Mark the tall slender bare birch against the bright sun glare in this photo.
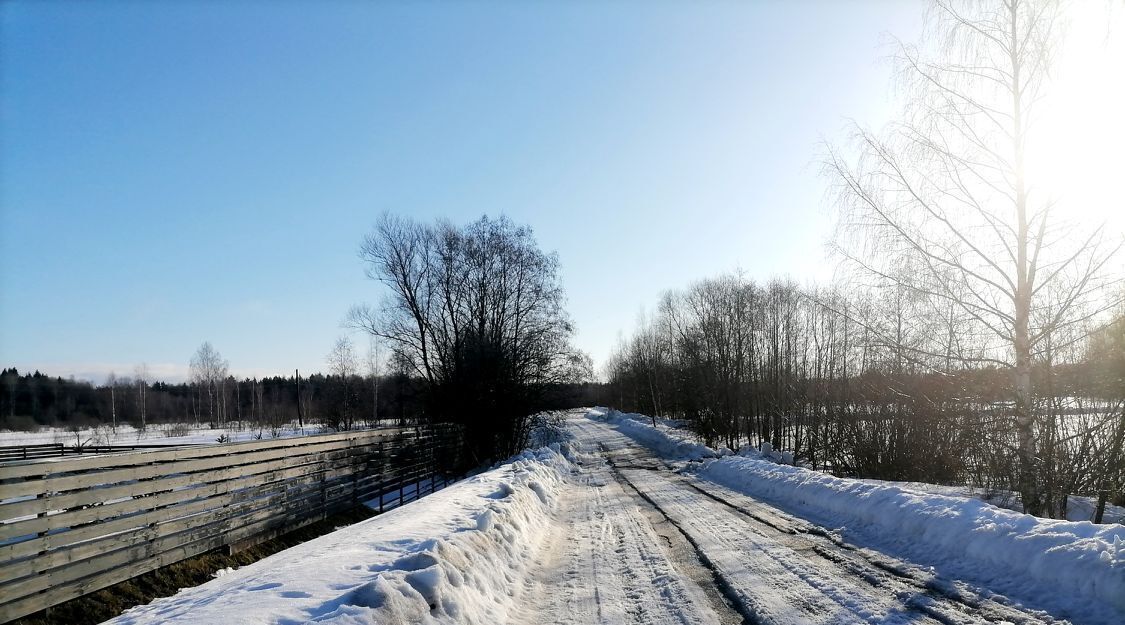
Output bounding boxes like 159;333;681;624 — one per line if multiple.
826;0;1121;514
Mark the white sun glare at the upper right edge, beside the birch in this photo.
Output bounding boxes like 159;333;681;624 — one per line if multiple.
1026;2;1125;233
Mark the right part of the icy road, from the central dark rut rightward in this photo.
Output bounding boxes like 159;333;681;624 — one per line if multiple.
573;422;1055;625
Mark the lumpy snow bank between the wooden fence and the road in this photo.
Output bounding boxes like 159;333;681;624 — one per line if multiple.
109;445;576;625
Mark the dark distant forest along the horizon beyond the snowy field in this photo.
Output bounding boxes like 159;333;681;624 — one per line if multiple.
0;368;601;431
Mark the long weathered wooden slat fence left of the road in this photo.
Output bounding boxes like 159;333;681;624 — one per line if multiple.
0;428;459;623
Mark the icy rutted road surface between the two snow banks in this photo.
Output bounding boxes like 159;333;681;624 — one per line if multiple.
528;418;1054;625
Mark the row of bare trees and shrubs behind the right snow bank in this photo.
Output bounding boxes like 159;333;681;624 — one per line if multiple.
606;274;1125;516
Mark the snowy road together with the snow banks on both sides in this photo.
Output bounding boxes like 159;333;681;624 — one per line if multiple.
101;410;1125;625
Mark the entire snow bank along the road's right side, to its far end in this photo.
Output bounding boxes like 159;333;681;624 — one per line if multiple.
603;408;1125;623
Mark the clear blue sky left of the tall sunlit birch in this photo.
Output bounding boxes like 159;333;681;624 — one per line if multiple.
0;0;924;379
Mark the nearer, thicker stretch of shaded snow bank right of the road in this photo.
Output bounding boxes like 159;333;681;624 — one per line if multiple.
698;456;1125;612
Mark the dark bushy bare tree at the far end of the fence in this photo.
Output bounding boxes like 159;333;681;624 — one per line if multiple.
349;215;583;460
